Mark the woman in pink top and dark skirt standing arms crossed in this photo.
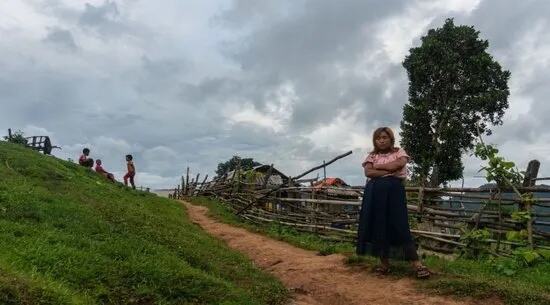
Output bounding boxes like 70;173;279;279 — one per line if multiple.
357;127;430;278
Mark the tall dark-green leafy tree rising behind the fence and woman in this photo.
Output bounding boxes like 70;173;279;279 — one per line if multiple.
401;19;510;187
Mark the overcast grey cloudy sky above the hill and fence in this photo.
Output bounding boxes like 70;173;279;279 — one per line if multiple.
0;0;550;187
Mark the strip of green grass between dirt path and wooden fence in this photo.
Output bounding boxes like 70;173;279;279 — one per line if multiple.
190;197;550;305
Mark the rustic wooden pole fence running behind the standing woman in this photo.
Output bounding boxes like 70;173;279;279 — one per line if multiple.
170;153;550;256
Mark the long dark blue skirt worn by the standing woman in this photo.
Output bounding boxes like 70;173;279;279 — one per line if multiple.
357;177;418;260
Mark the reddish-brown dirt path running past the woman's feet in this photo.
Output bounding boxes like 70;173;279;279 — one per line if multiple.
184;203;492;305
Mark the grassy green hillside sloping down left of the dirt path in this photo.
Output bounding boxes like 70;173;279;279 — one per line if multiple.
0;142;288;304
